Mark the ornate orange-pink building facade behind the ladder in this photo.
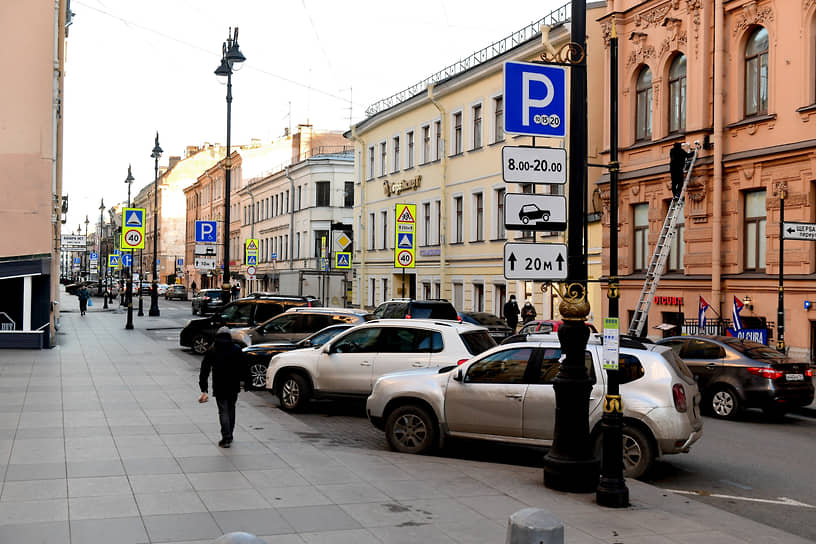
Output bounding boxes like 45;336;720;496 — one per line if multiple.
599;0;816;360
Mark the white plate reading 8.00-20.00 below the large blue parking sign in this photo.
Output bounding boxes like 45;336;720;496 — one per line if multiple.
502;146;567;185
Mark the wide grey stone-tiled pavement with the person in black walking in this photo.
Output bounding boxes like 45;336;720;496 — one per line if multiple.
0;304;807;544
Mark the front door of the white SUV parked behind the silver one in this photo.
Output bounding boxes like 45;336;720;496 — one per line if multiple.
315;327;382;395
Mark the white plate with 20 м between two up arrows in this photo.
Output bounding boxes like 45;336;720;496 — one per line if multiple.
504;242;567;281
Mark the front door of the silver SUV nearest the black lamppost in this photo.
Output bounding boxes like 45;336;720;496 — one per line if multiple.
445;347;533;438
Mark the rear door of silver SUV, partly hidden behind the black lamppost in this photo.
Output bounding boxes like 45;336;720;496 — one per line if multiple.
522;347;604;440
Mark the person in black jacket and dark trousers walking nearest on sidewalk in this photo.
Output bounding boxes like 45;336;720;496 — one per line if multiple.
198;327;243;448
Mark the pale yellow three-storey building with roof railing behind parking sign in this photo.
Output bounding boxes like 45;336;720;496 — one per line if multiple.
348;2;604;320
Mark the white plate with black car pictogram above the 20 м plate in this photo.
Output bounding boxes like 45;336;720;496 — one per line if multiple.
504;193;567;231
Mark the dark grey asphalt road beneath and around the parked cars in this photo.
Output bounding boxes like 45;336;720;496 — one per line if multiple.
147;299;816;541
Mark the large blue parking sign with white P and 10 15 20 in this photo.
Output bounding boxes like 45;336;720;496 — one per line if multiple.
504;62;567;138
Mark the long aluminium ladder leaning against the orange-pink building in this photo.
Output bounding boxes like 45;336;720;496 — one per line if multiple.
628;142;700;337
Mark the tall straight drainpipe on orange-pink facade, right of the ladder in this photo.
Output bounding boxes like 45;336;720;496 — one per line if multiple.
711;0;725;315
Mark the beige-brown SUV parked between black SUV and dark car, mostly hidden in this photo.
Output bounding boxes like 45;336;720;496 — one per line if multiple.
232;306;374;347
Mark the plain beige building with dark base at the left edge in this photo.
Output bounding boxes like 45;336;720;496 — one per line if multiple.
0;0;72;348
